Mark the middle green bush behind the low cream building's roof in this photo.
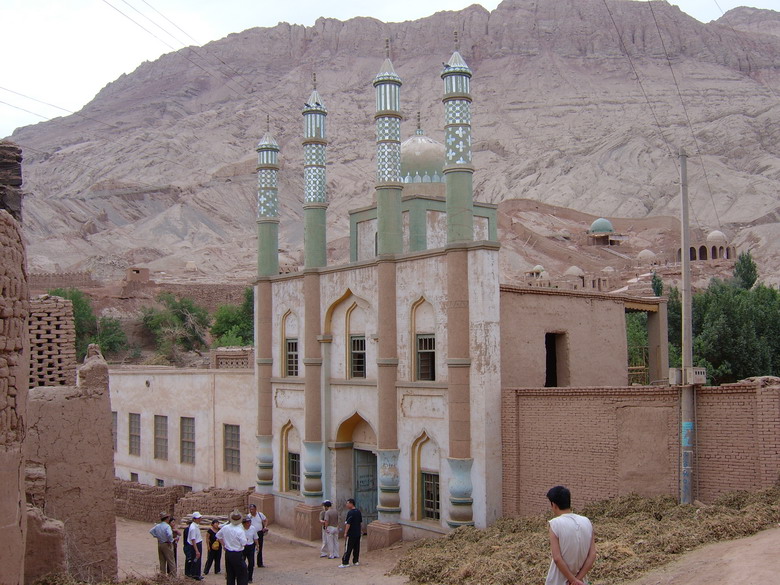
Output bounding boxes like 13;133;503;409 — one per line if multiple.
141;293;211;361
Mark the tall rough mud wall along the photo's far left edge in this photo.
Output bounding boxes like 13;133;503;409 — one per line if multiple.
0;209;29;583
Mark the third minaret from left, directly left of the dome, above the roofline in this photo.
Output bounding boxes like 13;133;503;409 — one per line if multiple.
374;40;403;256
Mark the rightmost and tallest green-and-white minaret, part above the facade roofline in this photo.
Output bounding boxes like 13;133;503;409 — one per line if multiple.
441;32;474;242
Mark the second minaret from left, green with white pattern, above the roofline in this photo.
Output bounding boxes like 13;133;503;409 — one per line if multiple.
303;75;328;268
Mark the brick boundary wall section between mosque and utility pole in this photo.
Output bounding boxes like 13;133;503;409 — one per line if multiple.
502;387;679;516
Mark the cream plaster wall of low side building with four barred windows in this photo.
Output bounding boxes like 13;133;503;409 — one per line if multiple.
109;368;257;490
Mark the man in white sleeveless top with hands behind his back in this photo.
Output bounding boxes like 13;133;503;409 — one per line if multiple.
545;485;596;585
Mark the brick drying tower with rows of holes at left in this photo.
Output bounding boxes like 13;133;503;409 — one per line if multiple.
28;295;76;388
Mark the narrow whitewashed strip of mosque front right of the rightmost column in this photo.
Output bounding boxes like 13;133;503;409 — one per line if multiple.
469;244;501;528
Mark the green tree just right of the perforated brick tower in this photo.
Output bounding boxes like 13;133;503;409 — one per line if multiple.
49;288;127;361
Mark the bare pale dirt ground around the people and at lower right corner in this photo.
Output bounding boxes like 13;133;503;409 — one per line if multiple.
117;518;780;585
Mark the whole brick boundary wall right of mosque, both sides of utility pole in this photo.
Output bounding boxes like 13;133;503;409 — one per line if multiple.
501;378;780;516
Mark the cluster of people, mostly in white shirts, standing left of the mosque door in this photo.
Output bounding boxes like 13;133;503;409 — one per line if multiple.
149;504;268;585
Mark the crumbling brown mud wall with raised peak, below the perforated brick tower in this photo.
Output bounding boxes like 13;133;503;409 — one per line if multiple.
24;346;117;581
